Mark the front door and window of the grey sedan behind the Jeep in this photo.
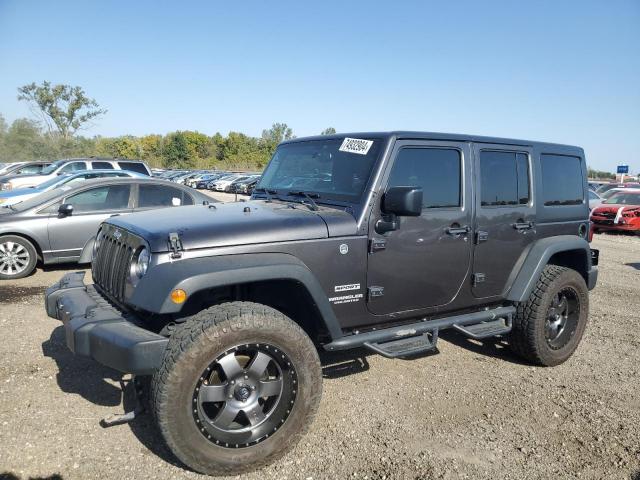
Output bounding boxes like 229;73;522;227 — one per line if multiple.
48;184;131;258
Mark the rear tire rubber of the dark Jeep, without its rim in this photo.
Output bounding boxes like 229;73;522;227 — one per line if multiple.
509;265;589;367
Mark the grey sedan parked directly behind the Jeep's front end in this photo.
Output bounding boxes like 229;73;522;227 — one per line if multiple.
0;178;214;280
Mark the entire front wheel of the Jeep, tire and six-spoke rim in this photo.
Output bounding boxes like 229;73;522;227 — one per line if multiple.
151;302;322;475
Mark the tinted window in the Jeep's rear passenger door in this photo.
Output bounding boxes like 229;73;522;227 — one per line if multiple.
480;150;530;206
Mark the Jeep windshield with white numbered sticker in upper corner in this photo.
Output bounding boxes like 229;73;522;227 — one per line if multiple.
257;138;382;203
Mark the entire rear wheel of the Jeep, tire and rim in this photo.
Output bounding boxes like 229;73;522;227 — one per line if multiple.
510;265;589;366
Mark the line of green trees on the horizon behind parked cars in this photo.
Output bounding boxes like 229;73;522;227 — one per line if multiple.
0;81;616;179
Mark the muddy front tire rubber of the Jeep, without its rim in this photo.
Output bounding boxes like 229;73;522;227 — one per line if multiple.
150;302;322;475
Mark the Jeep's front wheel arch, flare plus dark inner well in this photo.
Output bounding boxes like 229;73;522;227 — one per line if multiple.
127;253;342;339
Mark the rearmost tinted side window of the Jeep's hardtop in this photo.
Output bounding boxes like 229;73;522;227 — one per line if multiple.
540;154;584;206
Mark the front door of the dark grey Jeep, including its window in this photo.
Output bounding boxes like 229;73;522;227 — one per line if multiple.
367;141;472;315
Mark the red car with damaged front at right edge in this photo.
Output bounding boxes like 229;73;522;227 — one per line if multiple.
591;188;640;235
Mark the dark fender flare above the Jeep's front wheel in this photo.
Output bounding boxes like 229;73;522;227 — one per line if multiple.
127;253;342;339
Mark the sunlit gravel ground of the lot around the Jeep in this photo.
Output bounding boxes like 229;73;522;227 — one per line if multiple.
0;230;640;480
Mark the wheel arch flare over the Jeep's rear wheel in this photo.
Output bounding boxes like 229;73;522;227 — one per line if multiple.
506;235;591;302
